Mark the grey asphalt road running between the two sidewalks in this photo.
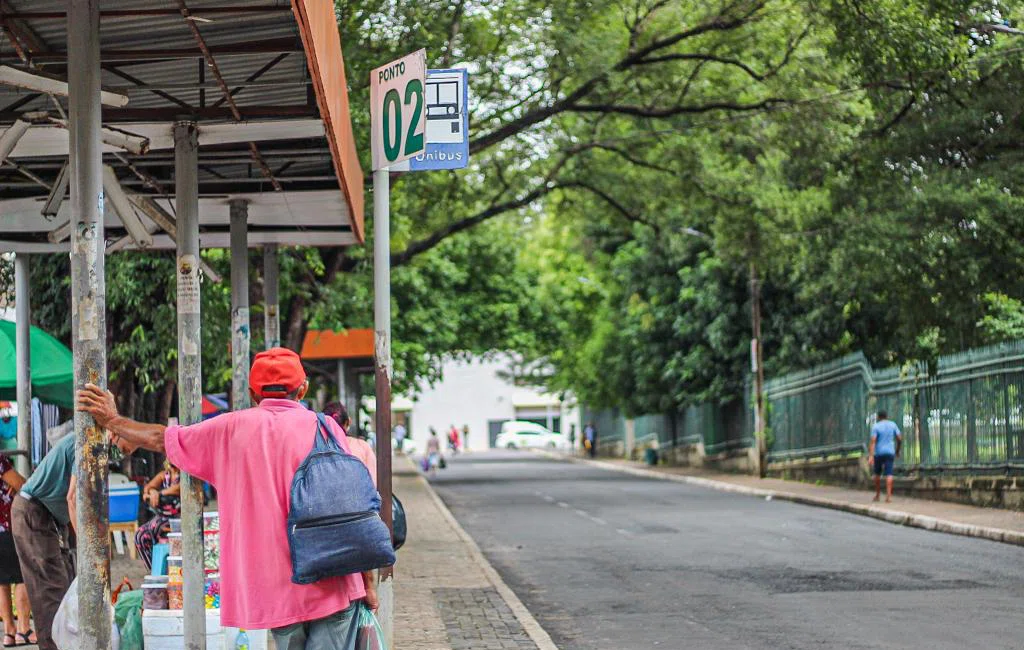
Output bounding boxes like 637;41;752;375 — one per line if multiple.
428;451;1024;650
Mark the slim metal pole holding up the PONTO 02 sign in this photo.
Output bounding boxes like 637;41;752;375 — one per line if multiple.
374;168;394;648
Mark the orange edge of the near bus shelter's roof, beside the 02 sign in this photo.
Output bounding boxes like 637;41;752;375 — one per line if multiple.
292;0;366;244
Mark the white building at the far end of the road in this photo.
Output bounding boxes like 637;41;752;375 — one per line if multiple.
392;357;581;451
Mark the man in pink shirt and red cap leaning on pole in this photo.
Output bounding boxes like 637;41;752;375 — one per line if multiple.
78;348;377;650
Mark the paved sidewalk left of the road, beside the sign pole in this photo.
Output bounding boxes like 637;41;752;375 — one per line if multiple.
394;456;557;650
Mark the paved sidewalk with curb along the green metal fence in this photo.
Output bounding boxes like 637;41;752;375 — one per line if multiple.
558;454;1024;546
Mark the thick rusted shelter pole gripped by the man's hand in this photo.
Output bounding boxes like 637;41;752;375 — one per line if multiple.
68;0;111;650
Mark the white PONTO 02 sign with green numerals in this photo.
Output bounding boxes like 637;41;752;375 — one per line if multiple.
370;49;427;170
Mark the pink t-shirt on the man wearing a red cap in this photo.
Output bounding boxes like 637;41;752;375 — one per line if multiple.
164;399;377;630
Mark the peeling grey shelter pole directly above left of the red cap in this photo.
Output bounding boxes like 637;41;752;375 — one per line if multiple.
230;199;250;410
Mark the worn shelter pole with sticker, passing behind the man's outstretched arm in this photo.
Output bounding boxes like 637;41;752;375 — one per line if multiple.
174;121;206;650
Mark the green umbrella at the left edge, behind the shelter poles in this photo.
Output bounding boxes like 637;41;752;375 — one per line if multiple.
0;320;75;408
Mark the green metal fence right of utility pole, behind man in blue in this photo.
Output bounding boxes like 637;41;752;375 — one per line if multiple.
765;341;1024;470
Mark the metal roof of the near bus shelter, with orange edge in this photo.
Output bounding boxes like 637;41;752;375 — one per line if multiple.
0;0;362;251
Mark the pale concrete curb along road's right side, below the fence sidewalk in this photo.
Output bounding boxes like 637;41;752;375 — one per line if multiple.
540;450;1024;547
